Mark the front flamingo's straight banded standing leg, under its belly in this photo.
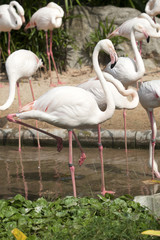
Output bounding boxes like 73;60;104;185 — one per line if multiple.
68;130;77;197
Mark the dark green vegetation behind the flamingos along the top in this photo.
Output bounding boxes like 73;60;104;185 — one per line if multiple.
0;0;147;71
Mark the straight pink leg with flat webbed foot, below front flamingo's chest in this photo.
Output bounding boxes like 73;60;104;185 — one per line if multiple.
98;124;115;195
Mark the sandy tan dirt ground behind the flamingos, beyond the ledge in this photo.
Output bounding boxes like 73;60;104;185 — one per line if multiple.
0;67;160;131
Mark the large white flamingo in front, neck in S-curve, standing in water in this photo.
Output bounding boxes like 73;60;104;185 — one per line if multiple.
7;39;138;197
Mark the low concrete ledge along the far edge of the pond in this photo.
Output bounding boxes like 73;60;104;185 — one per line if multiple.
0;128;160;148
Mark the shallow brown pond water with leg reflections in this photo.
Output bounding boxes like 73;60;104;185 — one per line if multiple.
0;146;160;200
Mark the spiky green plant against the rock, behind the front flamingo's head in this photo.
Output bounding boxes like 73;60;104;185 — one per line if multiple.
83;18;125;64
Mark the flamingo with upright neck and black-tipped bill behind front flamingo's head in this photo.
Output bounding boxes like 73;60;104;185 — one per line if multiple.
104;23;146;158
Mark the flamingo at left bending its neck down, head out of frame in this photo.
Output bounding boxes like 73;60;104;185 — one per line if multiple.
0;49;43;151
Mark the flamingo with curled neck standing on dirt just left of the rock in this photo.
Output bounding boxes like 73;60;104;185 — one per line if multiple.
25;2;64;86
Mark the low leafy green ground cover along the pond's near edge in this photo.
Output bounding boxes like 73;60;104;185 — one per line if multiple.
0;195;160;240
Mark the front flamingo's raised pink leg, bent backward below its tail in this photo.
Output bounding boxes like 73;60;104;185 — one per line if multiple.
7;113;63;152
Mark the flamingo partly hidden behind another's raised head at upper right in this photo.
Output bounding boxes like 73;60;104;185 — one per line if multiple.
108;13;160;54
